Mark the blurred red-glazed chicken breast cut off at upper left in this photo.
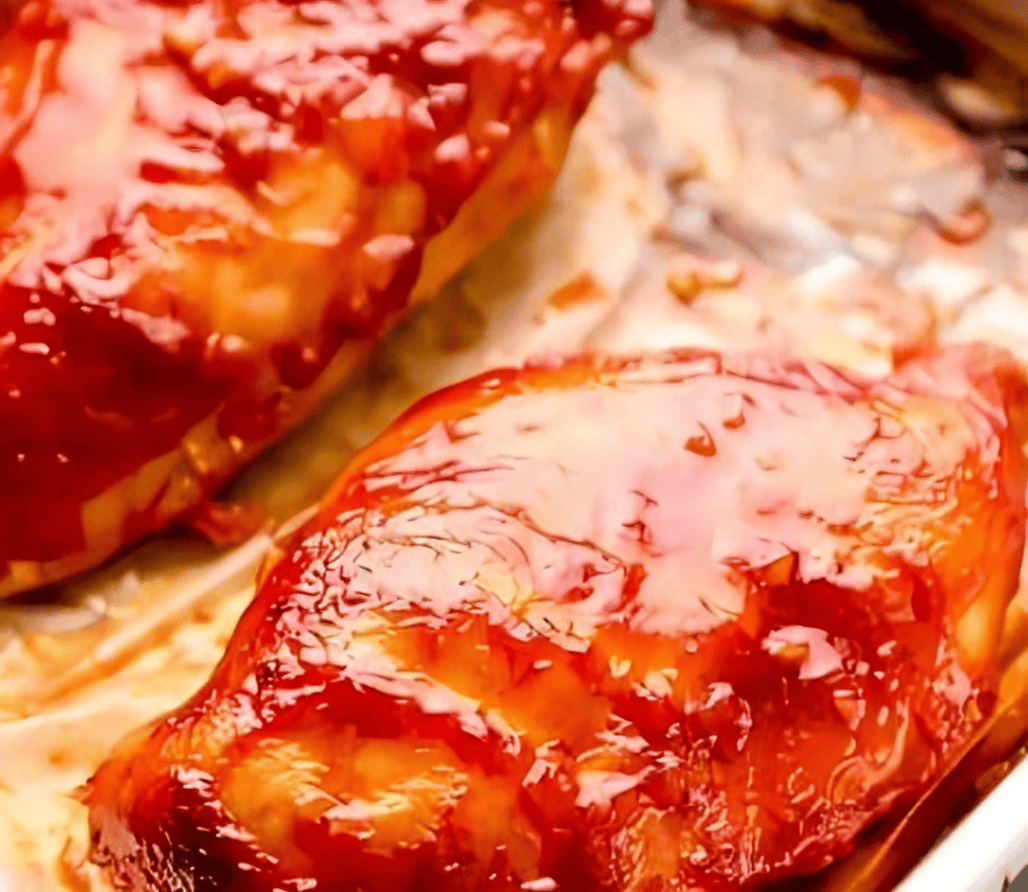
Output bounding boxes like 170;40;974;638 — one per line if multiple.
0;0;651;595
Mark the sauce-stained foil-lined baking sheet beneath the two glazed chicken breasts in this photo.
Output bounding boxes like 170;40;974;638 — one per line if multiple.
0;2;1028;892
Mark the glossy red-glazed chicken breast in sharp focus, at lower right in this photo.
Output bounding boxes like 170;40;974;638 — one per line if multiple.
84;349;1028;892
